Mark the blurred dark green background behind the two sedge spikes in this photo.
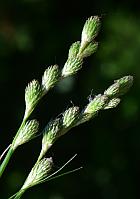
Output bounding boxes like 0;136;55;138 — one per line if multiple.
0;0;140;199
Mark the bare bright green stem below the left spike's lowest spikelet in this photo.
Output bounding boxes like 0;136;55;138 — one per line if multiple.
0;147;14;177
